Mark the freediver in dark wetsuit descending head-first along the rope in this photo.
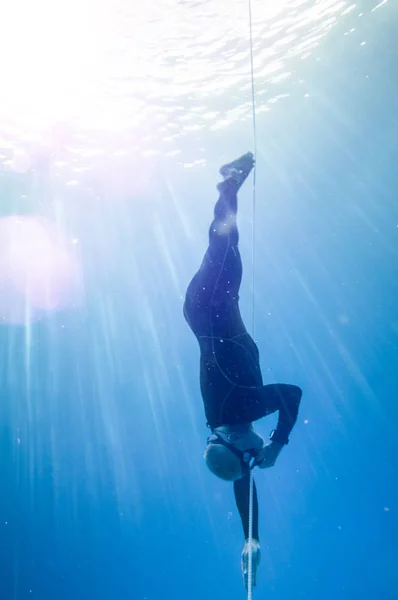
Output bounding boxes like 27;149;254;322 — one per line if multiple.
184;152;302;588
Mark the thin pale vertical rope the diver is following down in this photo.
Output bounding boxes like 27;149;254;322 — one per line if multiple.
247;0;257;600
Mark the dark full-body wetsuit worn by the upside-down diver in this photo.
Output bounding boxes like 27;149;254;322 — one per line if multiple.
184;180;301;539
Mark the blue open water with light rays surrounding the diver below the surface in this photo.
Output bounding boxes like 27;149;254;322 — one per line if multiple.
0;2;398;600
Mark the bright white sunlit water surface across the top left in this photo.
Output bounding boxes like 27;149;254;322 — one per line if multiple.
0;0;348;137
